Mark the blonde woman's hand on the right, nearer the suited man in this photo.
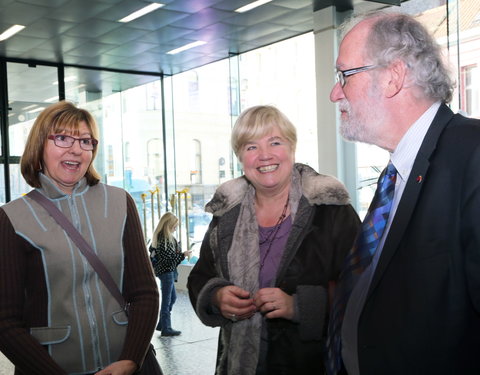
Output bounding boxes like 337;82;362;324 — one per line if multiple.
253;288;295;320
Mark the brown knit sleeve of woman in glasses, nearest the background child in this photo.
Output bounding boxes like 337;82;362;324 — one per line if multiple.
120;194;159;365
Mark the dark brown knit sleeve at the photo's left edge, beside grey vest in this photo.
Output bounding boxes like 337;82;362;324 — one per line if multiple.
0;208;66;375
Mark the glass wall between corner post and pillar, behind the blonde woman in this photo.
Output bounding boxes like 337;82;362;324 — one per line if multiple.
172;33;318;257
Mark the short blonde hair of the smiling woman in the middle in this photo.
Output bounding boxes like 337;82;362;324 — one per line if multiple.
231;105;297;159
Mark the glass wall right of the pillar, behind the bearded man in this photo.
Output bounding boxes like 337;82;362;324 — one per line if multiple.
356;0;480;217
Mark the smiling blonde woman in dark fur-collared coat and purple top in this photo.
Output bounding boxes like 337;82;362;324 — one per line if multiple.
188;106;359;375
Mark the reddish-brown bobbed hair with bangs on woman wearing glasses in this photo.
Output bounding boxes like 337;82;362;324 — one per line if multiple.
20;101;100;188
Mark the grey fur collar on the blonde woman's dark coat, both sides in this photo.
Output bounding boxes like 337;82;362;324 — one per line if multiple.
205;163;350;216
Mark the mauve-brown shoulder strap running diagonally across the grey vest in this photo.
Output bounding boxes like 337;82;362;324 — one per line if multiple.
27;190;127;311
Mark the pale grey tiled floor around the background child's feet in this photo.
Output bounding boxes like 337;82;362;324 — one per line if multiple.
0;291;219;375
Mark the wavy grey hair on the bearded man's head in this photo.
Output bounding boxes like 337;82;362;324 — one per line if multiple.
341;11;455;103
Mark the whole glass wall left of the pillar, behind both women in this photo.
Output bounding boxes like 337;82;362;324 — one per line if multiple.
2;30;317;255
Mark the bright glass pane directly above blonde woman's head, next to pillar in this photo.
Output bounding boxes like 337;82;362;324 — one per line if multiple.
239;33;318;170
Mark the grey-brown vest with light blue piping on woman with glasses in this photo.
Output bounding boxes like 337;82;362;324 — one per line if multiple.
2;175;128;374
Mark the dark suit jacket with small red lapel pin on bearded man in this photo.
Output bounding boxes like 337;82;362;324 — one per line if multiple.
358;105;480;375
